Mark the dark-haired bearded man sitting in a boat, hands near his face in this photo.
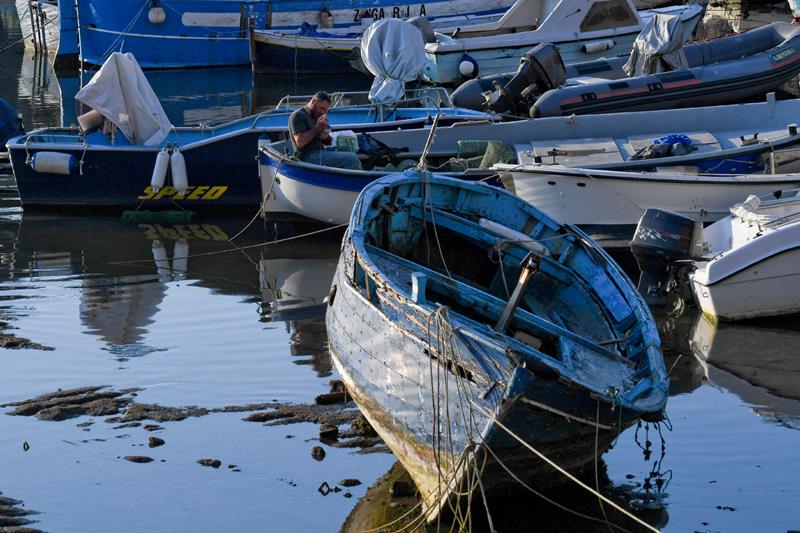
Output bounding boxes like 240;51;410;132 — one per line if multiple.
289;91;361;170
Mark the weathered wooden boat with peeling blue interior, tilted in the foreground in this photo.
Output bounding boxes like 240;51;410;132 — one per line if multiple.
326;170;668;519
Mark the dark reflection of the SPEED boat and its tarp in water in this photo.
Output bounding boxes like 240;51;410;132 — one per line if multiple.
4;215;263;358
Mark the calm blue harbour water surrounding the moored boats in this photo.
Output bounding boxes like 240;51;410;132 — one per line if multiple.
0;0;800;532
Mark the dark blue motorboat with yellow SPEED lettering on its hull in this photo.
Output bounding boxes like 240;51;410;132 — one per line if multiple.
8;102;489;210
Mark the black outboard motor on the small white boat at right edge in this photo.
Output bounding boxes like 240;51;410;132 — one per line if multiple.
631;208;703;304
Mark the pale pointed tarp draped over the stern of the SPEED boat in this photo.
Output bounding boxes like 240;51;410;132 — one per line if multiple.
75;52;172;146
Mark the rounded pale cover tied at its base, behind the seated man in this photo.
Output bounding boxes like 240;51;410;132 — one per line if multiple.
361;18;426;104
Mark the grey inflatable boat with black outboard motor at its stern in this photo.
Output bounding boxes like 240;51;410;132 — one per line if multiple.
452;22;800;118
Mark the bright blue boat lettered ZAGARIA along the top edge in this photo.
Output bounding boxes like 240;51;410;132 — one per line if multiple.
76;0;512;68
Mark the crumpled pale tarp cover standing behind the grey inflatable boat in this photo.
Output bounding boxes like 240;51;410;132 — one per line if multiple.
622;13;689;76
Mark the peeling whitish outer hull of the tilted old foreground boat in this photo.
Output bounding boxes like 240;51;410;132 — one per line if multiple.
327;260;638;517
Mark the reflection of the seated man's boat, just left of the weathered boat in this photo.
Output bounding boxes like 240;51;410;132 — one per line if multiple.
258;227;342;377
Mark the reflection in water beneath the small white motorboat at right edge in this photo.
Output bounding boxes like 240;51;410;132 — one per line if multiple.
690;315;800;429
